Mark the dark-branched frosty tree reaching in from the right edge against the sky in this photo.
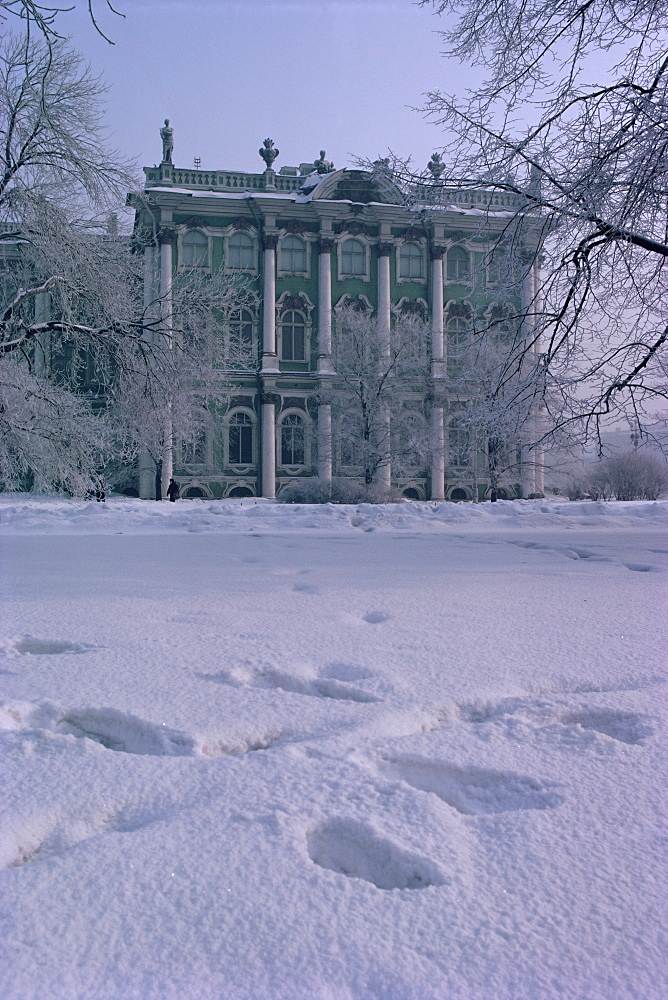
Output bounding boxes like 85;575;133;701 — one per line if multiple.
398;0;668;446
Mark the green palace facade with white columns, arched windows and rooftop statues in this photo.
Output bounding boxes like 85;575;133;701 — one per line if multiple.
129;133;543;500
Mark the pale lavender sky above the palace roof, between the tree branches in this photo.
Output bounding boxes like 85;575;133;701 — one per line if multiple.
58;0;474;182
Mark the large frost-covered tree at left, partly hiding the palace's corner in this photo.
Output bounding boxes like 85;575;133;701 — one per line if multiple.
0;34;249;492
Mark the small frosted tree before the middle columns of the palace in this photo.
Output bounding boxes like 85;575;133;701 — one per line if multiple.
333;305;430;486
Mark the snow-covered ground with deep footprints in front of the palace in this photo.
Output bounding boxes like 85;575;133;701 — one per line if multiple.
0;494;668;1000
